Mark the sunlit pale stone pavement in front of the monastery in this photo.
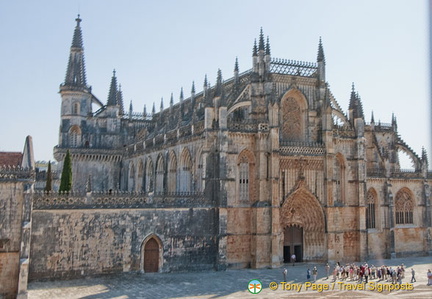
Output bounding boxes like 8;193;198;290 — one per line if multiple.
28;257;432;299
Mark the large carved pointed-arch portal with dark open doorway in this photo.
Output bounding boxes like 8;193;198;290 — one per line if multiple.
280;181;326;261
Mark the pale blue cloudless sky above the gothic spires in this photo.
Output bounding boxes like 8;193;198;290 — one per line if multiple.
0;0;430;166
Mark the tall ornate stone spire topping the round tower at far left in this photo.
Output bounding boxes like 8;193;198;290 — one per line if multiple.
61;15;90;90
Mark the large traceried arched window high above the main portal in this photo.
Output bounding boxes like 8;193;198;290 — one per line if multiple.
281;97;304;141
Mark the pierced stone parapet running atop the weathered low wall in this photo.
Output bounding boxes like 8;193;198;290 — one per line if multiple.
33;191;209;210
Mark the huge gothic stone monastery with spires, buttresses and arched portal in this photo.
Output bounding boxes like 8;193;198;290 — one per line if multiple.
0;17;432;298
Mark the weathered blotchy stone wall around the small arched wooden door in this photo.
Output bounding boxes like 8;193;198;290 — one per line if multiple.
30;204;217;280
